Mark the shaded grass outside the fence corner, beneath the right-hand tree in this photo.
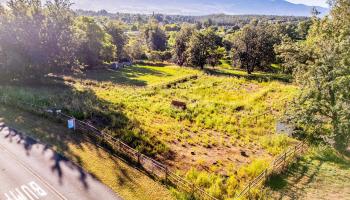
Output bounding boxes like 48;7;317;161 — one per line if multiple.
267;147;350;200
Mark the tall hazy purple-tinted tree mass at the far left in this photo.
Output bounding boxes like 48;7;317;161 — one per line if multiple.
0;0;76;78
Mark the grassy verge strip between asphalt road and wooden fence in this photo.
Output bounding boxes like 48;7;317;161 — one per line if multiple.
0;106;173;200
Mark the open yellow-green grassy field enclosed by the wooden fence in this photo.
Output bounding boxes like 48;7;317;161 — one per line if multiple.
0;65;298;198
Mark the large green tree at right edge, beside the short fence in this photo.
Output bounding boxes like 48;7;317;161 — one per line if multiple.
288;0;350;150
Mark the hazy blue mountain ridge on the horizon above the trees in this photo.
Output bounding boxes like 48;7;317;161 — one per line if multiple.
0;0;328;16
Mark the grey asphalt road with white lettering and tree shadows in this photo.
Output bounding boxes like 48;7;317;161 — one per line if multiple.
0;124;121;200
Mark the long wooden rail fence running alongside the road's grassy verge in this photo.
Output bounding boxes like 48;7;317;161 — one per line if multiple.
0;98;217;200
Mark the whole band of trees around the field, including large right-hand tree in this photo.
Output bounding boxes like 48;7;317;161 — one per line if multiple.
0;0;350;149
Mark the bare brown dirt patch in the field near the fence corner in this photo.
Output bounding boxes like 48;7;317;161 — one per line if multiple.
164;132;272;176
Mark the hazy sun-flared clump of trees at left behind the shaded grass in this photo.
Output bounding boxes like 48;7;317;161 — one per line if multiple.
0;0;126;78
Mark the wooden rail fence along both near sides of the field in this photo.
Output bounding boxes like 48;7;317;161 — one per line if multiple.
0;97;305;200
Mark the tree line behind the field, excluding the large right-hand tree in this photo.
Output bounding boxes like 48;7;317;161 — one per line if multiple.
0;0;308;77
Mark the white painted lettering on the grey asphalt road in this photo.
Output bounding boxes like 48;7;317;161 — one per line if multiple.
4;181;47;200
